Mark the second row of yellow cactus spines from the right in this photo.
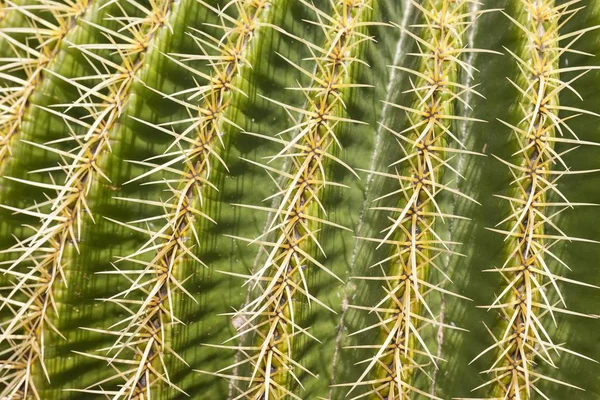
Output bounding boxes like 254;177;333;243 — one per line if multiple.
340;0;480;399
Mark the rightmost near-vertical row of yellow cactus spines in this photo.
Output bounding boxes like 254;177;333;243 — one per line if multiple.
478;0;598;399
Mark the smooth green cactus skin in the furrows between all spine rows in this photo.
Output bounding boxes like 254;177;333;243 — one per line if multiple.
0;0;600;400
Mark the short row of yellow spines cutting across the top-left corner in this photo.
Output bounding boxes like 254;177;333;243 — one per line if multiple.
0;0;90;167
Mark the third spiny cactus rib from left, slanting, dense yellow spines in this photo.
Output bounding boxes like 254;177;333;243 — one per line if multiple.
86;0;271;399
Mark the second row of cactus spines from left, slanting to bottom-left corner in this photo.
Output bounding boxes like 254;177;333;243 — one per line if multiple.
0;3;173;399
